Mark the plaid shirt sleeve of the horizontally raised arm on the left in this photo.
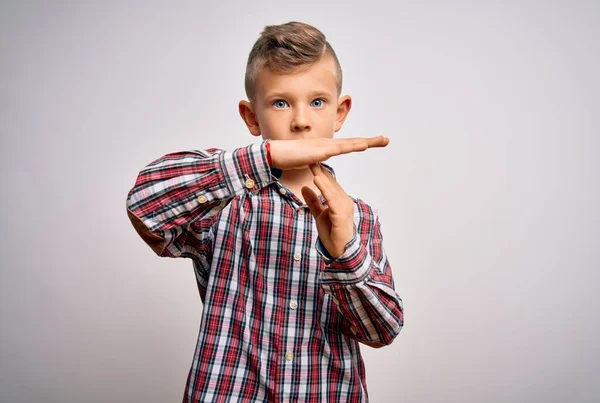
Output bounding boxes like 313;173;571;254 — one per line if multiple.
126;141;278;259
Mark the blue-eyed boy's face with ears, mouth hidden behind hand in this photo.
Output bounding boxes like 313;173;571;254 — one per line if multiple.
239;54;352;140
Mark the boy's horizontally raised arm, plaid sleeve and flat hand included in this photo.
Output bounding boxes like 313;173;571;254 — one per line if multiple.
127;136;389;257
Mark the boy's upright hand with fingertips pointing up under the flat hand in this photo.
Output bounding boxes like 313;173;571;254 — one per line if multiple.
302;164;354;258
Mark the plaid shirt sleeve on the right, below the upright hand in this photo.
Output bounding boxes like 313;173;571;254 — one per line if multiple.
316;207;404;347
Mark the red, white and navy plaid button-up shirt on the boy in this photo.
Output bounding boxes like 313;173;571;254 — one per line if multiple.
127;141;404;403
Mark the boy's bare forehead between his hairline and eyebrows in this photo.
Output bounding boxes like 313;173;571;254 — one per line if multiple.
256;55;337;98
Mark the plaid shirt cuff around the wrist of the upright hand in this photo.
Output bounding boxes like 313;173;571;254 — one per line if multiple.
315;225;371;285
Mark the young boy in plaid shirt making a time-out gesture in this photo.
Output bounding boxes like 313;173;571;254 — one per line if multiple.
127;22;404;402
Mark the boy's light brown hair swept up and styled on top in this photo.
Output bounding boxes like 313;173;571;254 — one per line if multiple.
244;21;342;102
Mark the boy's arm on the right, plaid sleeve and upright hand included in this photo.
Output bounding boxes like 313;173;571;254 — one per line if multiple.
302;164;404;347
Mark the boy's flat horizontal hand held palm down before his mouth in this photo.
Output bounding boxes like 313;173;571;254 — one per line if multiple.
269;136;390;172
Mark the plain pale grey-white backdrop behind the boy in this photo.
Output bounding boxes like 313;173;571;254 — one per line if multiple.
0;0;600;403
